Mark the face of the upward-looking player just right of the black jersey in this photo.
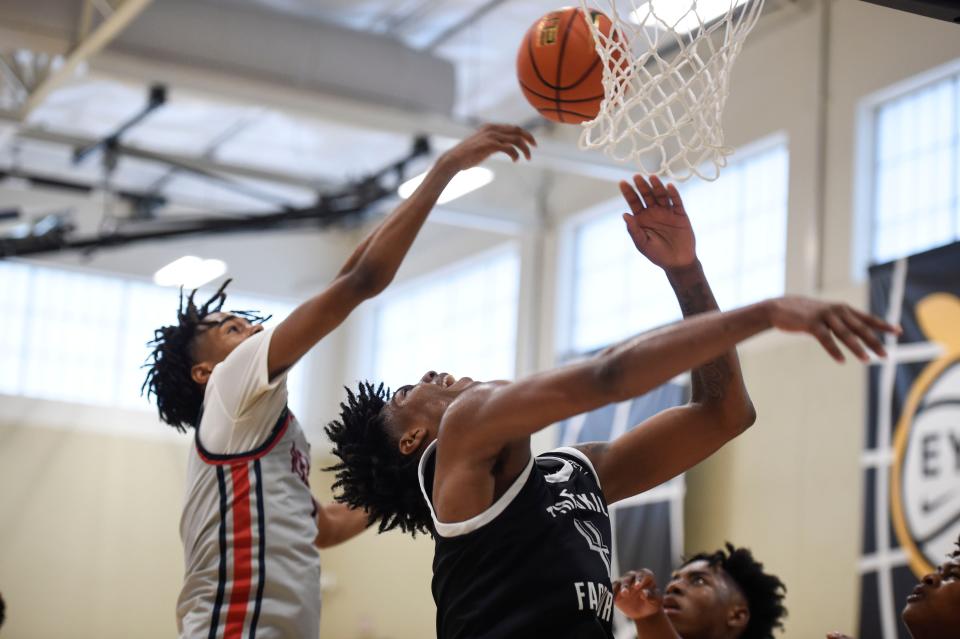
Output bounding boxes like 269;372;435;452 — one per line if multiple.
663;560;744;639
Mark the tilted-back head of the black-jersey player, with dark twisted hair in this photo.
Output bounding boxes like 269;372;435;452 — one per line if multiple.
326;371;476;535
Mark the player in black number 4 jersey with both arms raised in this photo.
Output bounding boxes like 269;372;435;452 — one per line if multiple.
327;176;896;639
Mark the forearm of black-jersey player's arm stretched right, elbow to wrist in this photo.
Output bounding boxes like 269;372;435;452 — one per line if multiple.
597;302;771;401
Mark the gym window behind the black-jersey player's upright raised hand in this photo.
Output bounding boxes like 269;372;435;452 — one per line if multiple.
560;136;789;355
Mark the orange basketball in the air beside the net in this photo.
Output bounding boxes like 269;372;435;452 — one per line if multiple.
517;7;610;123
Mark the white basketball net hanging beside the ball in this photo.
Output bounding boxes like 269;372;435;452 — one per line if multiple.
580;0;764;181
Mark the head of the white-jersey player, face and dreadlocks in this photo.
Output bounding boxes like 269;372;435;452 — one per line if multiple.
142;280;269;432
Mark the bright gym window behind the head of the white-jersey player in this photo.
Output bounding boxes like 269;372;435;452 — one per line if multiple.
0;260;305;412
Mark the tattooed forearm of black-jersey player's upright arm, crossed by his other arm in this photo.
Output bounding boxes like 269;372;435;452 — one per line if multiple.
667;260;753;425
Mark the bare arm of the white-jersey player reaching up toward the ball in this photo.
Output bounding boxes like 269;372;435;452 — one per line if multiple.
268;124;536;377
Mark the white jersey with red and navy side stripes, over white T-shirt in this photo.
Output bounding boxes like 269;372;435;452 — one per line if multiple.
177;330;320;639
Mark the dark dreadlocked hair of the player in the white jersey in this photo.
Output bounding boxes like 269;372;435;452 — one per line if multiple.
140;279;270;433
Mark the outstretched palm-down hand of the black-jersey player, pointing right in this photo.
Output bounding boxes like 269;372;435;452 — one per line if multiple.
769;296;901;362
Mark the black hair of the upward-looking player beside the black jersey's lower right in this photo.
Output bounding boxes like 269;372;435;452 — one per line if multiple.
684;542;787;639
